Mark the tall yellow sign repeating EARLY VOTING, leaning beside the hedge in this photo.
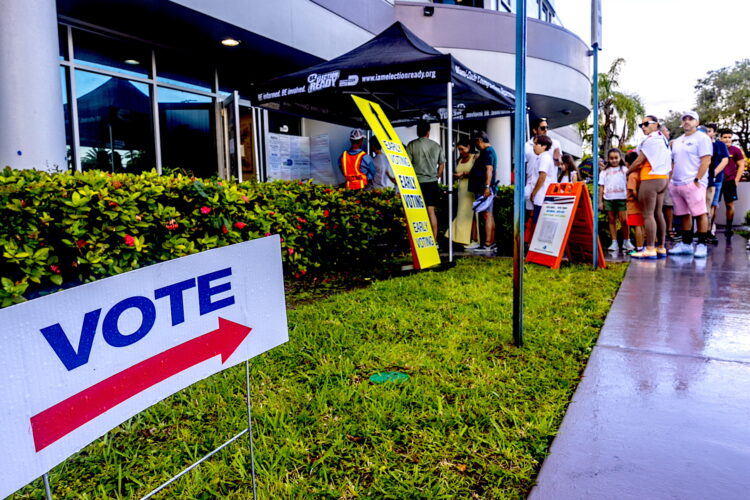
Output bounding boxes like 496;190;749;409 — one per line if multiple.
352;95;440;269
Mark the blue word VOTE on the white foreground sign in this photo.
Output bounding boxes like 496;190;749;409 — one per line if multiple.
40;267;235;371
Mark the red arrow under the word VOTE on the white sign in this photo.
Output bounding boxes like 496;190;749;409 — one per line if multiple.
31;318;252;451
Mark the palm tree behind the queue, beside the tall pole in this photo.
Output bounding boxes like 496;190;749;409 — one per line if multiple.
578;57;645;154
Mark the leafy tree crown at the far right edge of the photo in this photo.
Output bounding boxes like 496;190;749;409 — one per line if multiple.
695;59;750;154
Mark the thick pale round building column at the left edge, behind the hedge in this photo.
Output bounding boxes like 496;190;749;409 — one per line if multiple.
0;0;68;170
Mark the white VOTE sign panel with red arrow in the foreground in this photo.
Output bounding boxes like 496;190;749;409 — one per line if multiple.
0;236;288;497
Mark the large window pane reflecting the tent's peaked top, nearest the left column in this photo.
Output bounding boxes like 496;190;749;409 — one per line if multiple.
75;70;154;172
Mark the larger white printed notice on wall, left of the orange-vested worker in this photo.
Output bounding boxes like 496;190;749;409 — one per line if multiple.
266;134;310;181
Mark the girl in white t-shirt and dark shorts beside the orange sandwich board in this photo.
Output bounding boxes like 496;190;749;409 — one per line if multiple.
599;148;635;252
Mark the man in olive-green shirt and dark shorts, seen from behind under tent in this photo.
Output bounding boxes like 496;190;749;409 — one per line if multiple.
406;120;445;241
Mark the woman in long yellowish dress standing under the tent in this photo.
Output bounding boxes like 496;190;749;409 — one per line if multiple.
445;137;479;250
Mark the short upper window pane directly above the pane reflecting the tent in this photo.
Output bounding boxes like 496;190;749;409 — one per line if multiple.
73;30;151;77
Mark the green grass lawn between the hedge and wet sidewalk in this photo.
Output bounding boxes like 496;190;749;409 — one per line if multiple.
14;258;625;499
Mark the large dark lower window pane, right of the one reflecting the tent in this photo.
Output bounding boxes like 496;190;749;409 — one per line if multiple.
158;87;218;177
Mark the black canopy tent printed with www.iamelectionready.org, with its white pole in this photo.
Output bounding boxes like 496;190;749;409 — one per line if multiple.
254;22;515;261
